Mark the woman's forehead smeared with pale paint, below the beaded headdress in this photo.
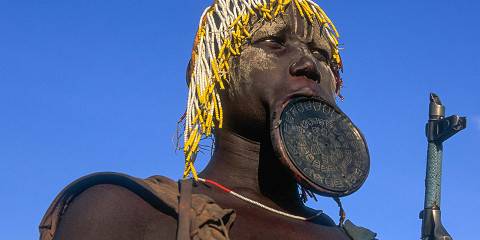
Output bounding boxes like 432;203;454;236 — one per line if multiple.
252;5;331;50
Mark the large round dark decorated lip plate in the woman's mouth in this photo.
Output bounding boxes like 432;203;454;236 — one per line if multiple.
271;97;370;197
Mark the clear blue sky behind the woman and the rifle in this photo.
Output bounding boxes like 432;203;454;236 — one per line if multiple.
0;0;480;239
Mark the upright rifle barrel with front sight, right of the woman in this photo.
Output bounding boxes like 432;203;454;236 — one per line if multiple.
420;93;467;240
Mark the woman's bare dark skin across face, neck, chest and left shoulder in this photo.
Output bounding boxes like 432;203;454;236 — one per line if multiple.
55;5;349;240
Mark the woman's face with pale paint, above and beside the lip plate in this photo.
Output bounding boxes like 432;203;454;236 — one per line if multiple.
222;7;336;140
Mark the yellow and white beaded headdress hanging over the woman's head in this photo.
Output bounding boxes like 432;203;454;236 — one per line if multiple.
183;0;342;179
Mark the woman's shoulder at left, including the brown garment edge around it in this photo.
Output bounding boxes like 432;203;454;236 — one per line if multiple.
40;173;178;240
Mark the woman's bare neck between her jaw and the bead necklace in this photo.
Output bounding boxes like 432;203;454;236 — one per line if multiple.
200;129;303;211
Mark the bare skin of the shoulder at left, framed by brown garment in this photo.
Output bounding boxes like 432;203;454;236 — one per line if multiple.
54;184;177;240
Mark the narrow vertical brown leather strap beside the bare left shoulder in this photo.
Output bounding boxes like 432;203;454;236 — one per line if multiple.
177;179;192;240
